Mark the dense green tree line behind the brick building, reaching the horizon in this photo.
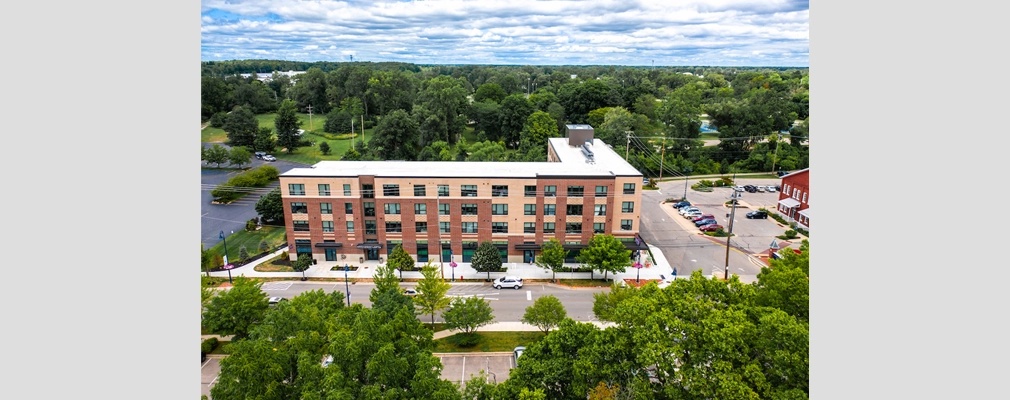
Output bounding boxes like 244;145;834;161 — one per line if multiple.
201;61;809;176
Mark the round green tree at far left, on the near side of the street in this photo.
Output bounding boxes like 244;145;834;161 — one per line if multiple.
203;277;268;338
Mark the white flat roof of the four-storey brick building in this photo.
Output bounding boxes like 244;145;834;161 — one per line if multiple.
281;137;642;179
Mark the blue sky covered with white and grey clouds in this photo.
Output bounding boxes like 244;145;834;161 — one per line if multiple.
200;0;810;67
